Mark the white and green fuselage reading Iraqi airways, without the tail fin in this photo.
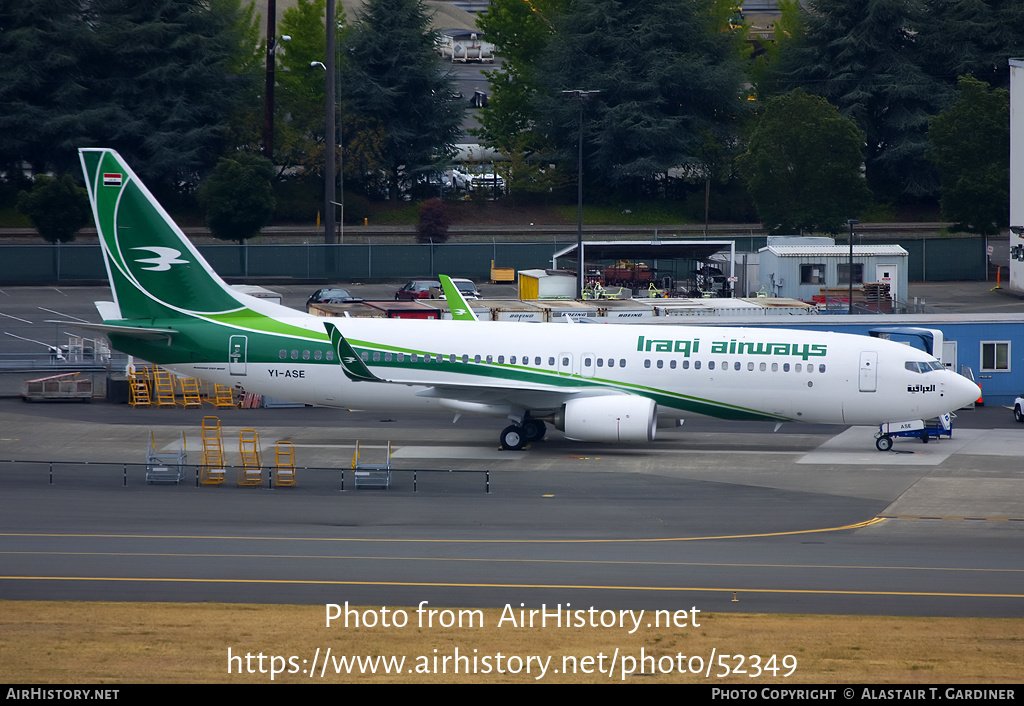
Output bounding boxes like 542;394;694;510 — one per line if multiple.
159;309;977;424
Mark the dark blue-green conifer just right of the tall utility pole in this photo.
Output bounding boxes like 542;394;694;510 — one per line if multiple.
341;0;462;199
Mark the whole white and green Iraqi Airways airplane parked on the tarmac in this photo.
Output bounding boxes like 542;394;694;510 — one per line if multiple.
80;149;980;449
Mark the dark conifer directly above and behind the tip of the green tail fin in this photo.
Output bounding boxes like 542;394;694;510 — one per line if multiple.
88;0;258;189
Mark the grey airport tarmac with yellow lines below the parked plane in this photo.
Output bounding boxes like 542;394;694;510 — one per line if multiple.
0;400;1024;617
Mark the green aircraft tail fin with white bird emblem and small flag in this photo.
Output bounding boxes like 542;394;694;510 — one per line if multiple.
79;148;244;320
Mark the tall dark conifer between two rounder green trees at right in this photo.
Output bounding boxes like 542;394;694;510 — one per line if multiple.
784;0;951;198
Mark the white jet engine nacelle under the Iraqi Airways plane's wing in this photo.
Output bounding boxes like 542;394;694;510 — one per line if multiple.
555;394;657;442
